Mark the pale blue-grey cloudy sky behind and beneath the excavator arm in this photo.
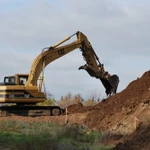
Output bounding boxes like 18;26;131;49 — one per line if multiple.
0;0;150;100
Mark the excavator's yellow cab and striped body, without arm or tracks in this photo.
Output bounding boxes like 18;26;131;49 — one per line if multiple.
0;74;45;104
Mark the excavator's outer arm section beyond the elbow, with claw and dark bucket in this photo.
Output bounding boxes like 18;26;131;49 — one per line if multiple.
79;34;119;96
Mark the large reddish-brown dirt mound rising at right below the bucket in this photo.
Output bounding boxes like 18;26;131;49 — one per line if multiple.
68;71;150;150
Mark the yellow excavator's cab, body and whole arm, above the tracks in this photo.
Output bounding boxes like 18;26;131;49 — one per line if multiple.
0;31;119;116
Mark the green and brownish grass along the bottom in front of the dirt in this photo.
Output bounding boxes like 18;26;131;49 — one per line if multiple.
0;120;112;150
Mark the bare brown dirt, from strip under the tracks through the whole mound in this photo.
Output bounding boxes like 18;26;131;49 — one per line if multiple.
0;71;150;150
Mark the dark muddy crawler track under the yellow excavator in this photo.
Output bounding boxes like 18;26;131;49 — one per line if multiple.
0;105;64;117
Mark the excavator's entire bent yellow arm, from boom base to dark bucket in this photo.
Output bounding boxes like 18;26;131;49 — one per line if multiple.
26;31;119;95
